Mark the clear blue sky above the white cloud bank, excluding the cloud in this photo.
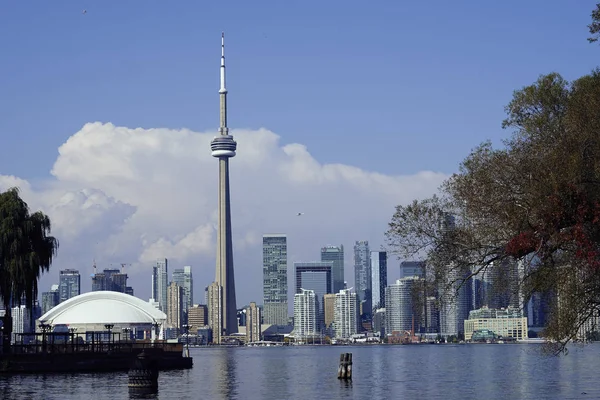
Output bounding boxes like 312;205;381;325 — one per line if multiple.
0;0;600;179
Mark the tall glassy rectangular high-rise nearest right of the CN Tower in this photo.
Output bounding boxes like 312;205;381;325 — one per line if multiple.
263;234;288;325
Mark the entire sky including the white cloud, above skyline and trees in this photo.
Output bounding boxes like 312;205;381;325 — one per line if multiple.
0;0;600;305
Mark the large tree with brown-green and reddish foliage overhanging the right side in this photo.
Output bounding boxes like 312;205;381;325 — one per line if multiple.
387;70;600;350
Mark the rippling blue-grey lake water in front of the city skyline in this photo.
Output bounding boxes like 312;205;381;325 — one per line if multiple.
0;344;600;400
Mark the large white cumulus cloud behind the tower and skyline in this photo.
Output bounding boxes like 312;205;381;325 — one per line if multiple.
0;122;446;305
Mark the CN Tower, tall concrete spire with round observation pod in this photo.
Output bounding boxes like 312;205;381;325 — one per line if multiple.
210;34;238;336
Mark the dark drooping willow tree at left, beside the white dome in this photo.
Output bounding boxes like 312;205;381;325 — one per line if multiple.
0;188;58;352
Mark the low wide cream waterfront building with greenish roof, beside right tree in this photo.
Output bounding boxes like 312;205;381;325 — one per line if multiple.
464;306;527;340
